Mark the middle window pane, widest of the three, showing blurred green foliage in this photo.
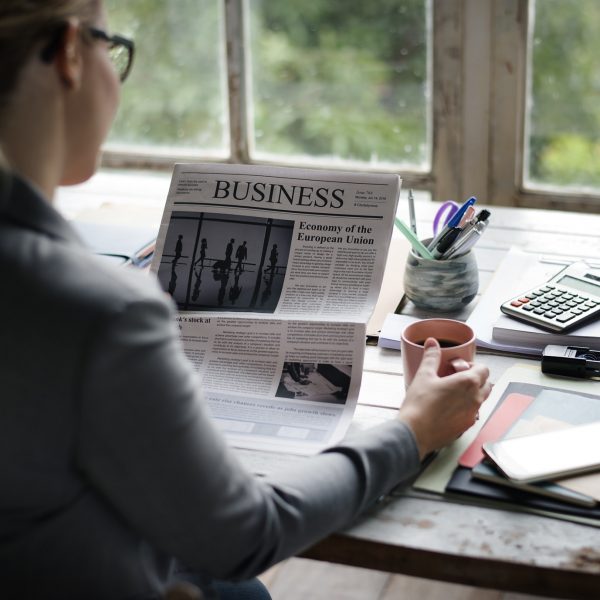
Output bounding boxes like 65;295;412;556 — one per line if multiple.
249;0;430;170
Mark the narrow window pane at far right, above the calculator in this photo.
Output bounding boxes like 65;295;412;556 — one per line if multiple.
525;0;600;191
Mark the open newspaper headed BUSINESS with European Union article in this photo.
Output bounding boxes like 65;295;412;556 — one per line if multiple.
151;164;401;454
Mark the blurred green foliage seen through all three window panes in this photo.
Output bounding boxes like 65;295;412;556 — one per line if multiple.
107;0;600;187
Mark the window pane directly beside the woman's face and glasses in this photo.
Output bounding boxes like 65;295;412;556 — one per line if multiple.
106;0;229;155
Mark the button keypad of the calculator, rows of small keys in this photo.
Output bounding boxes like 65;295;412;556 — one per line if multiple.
502;284;600;331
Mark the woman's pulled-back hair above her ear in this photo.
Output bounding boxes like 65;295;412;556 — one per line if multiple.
0;0;100;102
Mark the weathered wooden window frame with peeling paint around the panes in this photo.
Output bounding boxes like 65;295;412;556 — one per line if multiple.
102;0;600;212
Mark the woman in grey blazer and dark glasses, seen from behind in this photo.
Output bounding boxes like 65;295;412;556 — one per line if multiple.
0;0;490;600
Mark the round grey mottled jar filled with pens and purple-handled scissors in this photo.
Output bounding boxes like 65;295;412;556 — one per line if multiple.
396;195;490;312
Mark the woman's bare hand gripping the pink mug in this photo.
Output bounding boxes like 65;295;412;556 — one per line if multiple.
398;338;492;458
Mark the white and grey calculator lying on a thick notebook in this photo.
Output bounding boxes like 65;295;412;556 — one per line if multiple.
500;262;600;333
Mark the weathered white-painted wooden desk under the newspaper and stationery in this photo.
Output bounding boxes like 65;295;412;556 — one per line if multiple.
57;180;600;599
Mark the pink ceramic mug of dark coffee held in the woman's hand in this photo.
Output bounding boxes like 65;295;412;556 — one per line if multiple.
401;319;475;387
